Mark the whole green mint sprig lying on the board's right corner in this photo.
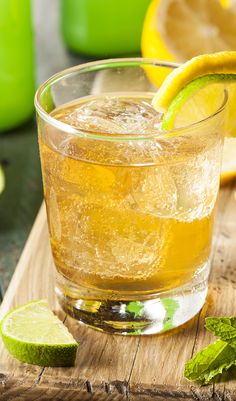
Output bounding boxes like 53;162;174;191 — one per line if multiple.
184;317;236;385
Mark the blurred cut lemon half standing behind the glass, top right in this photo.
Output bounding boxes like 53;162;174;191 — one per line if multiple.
141;0;236;85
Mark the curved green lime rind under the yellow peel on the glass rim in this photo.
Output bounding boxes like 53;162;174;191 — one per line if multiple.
162;74;236;130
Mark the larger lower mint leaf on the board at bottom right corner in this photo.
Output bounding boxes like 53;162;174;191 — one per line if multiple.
184;340;236;384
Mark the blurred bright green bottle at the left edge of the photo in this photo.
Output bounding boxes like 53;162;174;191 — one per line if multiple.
0;0;35;132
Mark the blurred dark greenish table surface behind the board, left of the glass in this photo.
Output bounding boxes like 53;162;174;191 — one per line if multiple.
0;0;88;294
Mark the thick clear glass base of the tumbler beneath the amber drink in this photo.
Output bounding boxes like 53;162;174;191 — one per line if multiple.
56;266;208;335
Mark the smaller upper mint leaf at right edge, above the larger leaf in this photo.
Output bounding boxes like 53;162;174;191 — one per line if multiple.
205;317;236;347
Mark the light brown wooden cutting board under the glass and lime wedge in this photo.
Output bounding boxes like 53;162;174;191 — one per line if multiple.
0;184;236;401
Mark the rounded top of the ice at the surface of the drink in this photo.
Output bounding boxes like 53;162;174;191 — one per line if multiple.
61;95;161;134
